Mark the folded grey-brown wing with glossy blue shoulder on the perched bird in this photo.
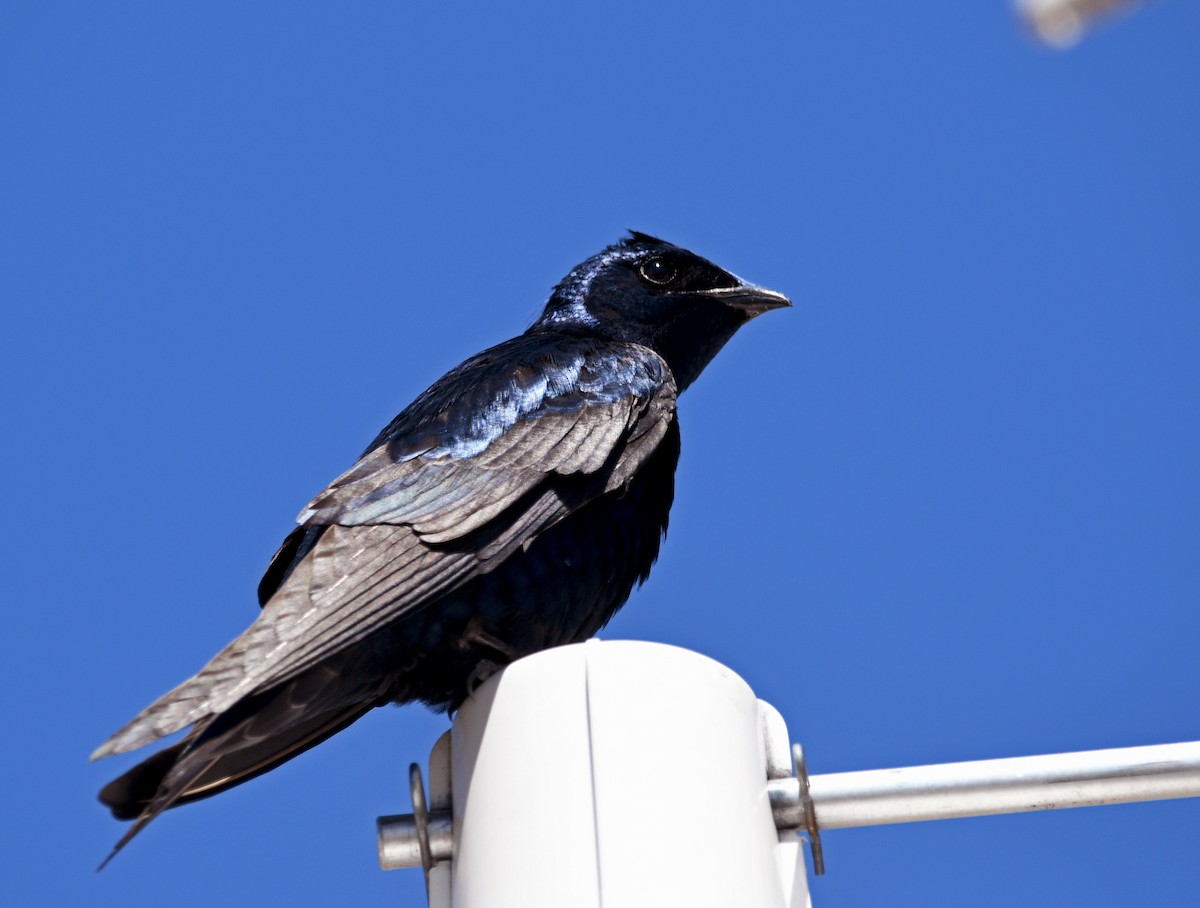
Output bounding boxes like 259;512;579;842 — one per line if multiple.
92;347;677;758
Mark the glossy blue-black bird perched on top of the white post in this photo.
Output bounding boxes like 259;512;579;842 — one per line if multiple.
92;230;791;866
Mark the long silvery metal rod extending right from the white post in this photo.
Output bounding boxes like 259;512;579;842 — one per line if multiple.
769;741;1200;829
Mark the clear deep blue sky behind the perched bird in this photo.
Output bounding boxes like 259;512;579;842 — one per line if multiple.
7;0;1200;908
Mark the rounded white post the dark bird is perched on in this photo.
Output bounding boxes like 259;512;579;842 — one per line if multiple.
380;641;809;908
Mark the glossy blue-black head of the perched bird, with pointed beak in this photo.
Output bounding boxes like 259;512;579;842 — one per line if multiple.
529;231;792;390
